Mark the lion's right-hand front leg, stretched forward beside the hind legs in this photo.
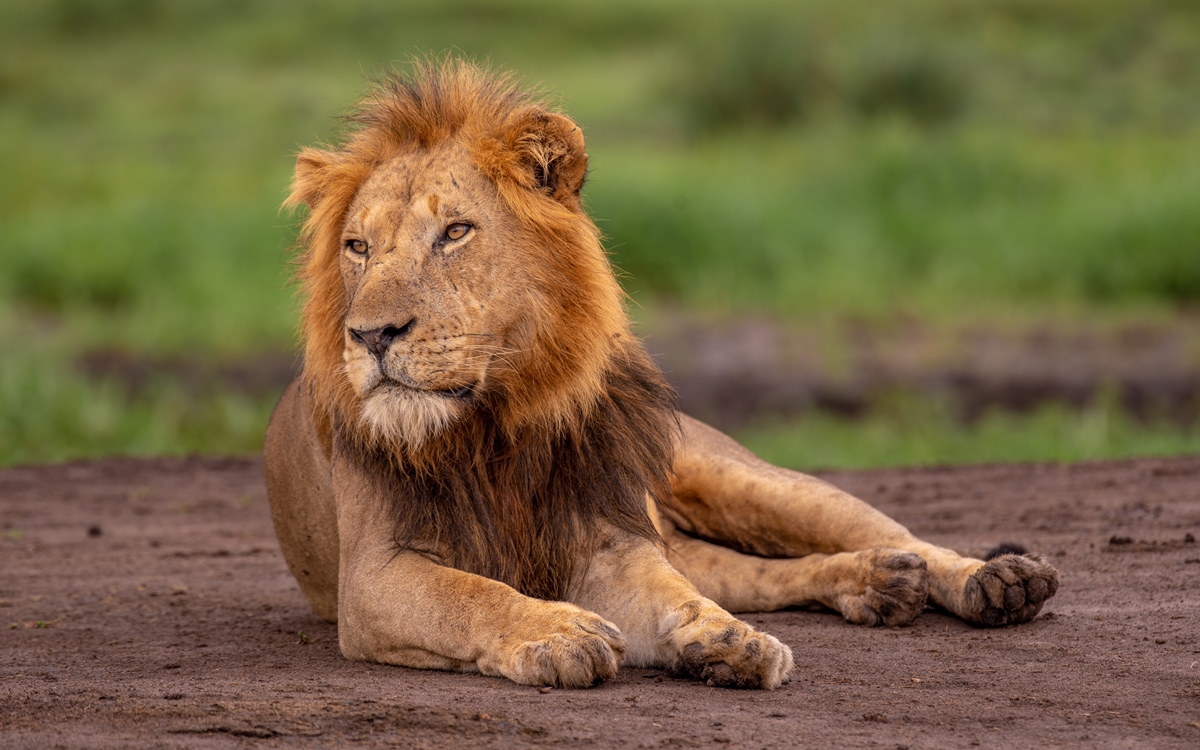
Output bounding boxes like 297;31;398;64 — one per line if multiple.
570;532;792;690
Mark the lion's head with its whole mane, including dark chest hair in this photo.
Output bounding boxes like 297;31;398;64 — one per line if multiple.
282;61;677;598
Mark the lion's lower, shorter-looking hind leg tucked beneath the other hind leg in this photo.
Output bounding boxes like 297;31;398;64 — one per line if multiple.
666;532;929;625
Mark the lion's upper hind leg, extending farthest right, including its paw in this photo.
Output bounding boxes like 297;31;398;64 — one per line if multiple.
662;416;1058;628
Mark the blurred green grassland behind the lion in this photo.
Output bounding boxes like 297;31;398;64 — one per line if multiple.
0;0;1200;468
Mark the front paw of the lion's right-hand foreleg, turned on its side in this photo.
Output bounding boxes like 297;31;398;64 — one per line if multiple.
672;602;792;690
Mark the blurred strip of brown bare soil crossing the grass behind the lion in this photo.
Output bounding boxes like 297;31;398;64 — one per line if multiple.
77;316;1200;430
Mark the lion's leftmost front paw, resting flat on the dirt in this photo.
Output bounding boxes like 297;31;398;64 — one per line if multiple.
480;604;625;688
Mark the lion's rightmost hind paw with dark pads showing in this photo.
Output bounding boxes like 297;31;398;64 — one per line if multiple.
962;553;1058;628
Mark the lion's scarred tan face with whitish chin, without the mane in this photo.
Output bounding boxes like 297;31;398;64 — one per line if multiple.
340;143;538;445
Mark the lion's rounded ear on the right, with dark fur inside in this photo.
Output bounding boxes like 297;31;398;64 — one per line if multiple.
517;112;588;211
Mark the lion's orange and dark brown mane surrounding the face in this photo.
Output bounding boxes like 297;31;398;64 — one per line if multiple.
279;60;678;599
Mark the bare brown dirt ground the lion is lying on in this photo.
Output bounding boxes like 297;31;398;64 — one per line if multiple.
0;457;1200;749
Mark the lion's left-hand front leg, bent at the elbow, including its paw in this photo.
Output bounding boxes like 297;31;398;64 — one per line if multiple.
334;453;625;688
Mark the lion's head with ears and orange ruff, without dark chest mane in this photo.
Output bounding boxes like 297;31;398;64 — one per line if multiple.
289;62;629;451
